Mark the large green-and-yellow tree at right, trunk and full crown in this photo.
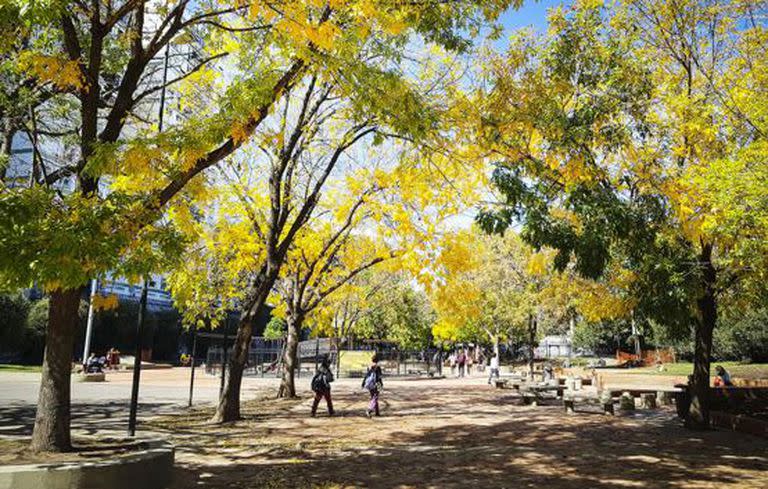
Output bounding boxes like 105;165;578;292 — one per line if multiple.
479;0;766;427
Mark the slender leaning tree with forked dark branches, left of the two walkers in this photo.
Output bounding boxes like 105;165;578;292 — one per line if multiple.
170;2;516;422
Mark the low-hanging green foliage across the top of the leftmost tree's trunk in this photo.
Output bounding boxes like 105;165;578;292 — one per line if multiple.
0;187;184;290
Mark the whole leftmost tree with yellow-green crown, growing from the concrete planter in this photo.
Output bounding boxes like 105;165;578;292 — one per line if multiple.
0;0;510;450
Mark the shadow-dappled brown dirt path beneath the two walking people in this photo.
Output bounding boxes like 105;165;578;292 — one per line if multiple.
140;380;768;489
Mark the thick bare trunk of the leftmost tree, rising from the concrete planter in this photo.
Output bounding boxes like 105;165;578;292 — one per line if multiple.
31;289;80;452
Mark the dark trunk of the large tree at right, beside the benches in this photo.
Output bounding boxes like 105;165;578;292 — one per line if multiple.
686;244;717;429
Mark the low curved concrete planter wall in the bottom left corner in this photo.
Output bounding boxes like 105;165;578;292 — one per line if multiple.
0;441;174;489
